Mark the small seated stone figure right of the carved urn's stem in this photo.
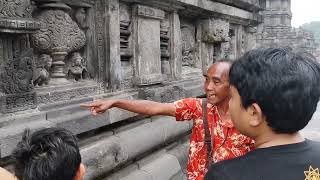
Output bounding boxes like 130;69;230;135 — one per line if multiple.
68;52;88;81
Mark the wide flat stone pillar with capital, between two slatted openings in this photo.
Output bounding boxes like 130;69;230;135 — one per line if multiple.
133;5;165;85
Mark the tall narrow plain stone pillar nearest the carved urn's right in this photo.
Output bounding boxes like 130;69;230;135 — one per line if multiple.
105;0;121;90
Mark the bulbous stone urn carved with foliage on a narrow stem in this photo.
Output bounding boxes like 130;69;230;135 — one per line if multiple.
31;9;86;83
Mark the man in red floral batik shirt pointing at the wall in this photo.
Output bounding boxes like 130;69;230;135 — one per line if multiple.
81;59;253;180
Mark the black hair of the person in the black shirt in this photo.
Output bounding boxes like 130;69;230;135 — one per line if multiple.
229;48;320;134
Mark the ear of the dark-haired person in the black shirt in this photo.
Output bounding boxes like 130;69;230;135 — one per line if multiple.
247;103;264;127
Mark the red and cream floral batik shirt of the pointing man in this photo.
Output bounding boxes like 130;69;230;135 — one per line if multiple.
174;98;253;180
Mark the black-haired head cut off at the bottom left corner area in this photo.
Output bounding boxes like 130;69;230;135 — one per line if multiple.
12;128;84;180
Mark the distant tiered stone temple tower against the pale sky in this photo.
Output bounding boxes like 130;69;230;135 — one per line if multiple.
257;0;317;55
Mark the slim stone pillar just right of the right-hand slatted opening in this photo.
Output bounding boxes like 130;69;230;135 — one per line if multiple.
170;12;182;79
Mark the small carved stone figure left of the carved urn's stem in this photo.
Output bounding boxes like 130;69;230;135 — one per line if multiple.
33;54;52;86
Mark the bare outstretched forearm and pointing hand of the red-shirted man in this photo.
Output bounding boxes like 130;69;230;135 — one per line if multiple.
80;99;176;117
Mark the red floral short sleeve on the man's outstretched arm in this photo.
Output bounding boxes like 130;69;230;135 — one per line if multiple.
174;98;202;121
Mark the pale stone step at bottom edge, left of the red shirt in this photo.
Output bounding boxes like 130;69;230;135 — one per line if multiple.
104;139;189;180
